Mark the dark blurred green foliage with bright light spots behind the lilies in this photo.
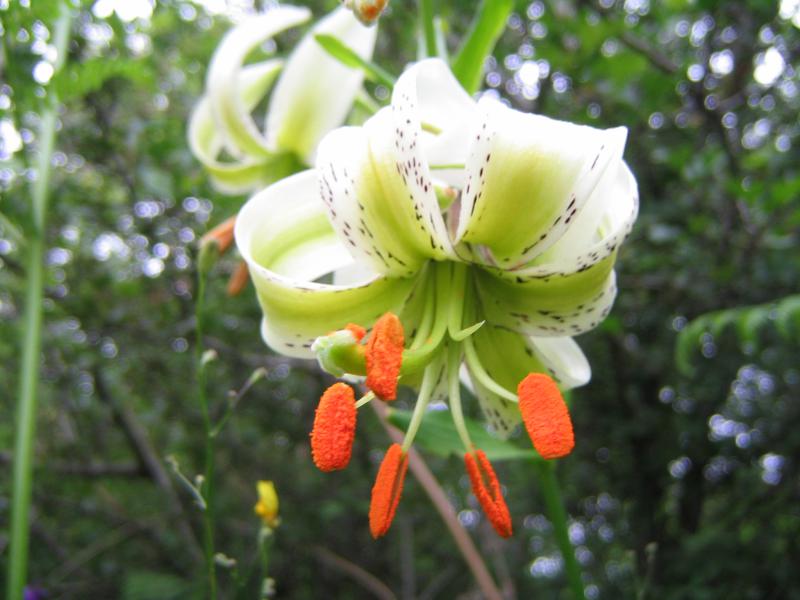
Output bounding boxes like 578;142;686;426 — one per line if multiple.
0;0;800;600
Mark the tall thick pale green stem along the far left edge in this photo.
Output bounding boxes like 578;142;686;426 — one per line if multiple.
6;3;71;600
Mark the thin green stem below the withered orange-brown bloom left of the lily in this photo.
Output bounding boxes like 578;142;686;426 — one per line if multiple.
195;262;217;600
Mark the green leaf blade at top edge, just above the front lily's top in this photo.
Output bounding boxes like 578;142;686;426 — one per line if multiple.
453;0;514;94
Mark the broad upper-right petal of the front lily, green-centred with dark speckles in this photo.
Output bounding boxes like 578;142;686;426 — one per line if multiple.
456;99;626;269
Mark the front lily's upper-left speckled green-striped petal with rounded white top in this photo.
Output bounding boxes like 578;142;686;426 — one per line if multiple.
317;60;475;276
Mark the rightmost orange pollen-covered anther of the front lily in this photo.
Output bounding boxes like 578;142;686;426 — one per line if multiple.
517;373;575;459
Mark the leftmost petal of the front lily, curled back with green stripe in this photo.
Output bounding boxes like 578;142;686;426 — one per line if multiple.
235;170;415;358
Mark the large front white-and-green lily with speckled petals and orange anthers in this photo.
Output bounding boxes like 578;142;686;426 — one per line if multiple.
235;59;638;537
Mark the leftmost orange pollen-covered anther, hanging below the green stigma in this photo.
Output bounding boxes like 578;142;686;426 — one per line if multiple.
311;382;356;471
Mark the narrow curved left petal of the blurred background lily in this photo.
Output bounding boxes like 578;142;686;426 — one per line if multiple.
206;6;311;156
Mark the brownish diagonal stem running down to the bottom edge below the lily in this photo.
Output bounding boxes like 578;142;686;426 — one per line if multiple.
370;402;503;600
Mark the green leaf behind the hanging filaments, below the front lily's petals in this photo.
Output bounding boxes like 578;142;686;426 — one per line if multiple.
388;408;541;460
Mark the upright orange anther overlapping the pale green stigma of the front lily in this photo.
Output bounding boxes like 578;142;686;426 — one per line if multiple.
366;312;404;400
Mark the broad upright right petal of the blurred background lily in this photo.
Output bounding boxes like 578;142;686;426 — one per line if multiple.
267;7;377;164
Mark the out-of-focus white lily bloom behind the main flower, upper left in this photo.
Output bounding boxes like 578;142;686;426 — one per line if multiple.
189;6;377;193
